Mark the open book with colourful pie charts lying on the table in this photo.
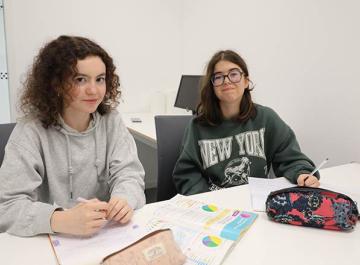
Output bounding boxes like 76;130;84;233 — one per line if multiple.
49;195;257;265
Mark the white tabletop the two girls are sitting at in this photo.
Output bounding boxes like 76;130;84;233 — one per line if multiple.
0;163;360;265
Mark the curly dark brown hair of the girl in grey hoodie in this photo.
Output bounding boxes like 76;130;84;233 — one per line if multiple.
20;36;121;128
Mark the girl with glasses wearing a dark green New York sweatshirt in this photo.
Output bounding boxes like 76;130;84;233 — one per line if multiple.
173;50;320;195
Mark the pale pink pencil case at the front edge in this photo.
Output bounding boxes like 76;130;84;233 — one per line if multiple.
101;229;186;265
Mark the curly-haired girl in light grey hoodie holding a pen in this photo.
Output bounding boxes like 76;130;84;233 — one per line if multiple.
0;36;145;236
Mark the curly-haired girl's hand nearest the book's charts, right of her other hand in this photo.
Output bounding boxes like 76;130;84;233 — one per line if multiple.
106;197;134;224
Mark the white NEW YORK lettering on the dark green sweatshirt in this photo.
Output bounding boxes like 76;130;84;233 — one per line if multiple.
198;128;266;169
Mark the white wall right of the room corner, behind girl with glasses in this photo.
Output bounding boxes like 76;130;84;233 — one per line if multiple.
182;0;360;166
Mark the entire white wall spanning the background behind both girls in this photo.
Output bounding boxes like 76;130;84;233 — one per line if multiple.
5;0;360;165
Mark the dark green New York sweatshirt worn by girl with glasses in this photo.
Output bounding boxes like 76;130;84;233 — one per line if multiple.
173;105;319;195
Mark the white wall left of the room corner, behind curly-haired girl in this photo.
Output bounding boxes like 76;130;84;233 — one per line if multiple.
5;0;181;115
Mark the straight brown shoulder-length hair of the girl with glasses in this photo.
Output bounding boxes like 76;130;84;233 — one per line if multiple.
196;50;256;126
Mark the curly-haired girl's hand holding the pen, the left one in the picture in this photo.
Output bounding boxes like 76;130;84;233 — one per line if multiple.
50;199;109;236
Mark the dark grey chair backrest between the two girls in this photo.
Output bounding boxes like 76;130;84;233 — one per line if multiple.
155;115;193;201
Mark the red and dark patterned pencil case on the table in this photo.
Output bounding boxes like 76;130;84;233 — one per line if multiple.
266;186;359;230
